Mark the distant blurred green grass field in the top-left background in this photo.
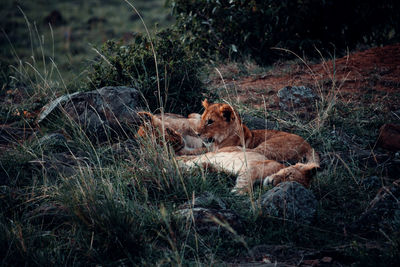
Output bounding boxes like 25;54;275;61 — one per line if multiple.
0;0;173;86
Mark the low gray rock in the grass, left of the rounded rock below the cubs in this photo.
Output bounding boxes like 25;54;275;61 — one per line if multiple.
175;192;242;233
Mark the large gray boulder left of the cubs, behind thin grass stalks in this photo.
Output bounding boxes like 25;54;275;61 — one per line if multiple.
38;86;140;142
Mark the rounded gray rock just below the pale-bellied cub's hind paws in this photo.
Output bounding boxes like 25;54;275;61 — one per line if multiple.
260;182;318;224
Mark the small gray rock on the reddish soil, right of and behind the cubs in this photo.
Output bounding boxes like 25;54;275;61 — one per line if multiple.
277;86;319;110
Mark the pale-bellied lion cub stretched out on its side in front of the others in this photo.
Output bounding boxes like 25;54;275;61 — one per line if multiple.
178;147;319;194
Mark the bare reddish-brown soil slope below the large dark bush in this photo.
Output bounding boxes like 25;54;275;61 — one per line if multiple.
218;44;400;111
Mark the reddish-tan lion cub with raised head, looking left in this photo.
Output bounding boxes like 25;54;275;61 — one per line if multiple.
197;99;319;165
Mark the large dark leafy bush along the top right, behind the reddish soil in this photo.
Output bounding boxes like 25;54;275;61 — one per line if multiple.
169;0;400;63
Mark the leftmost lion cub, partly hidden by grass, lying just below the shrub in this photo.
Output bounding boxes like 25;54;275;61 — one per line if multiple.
138;111;207;155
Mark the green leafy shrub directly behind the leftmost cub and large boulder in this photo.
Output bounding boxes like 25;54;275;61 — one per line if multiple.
88;30;209;113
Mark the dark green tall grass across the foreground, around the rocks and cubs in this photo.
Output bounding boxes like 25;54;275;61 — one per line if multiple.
0;3;399;266
